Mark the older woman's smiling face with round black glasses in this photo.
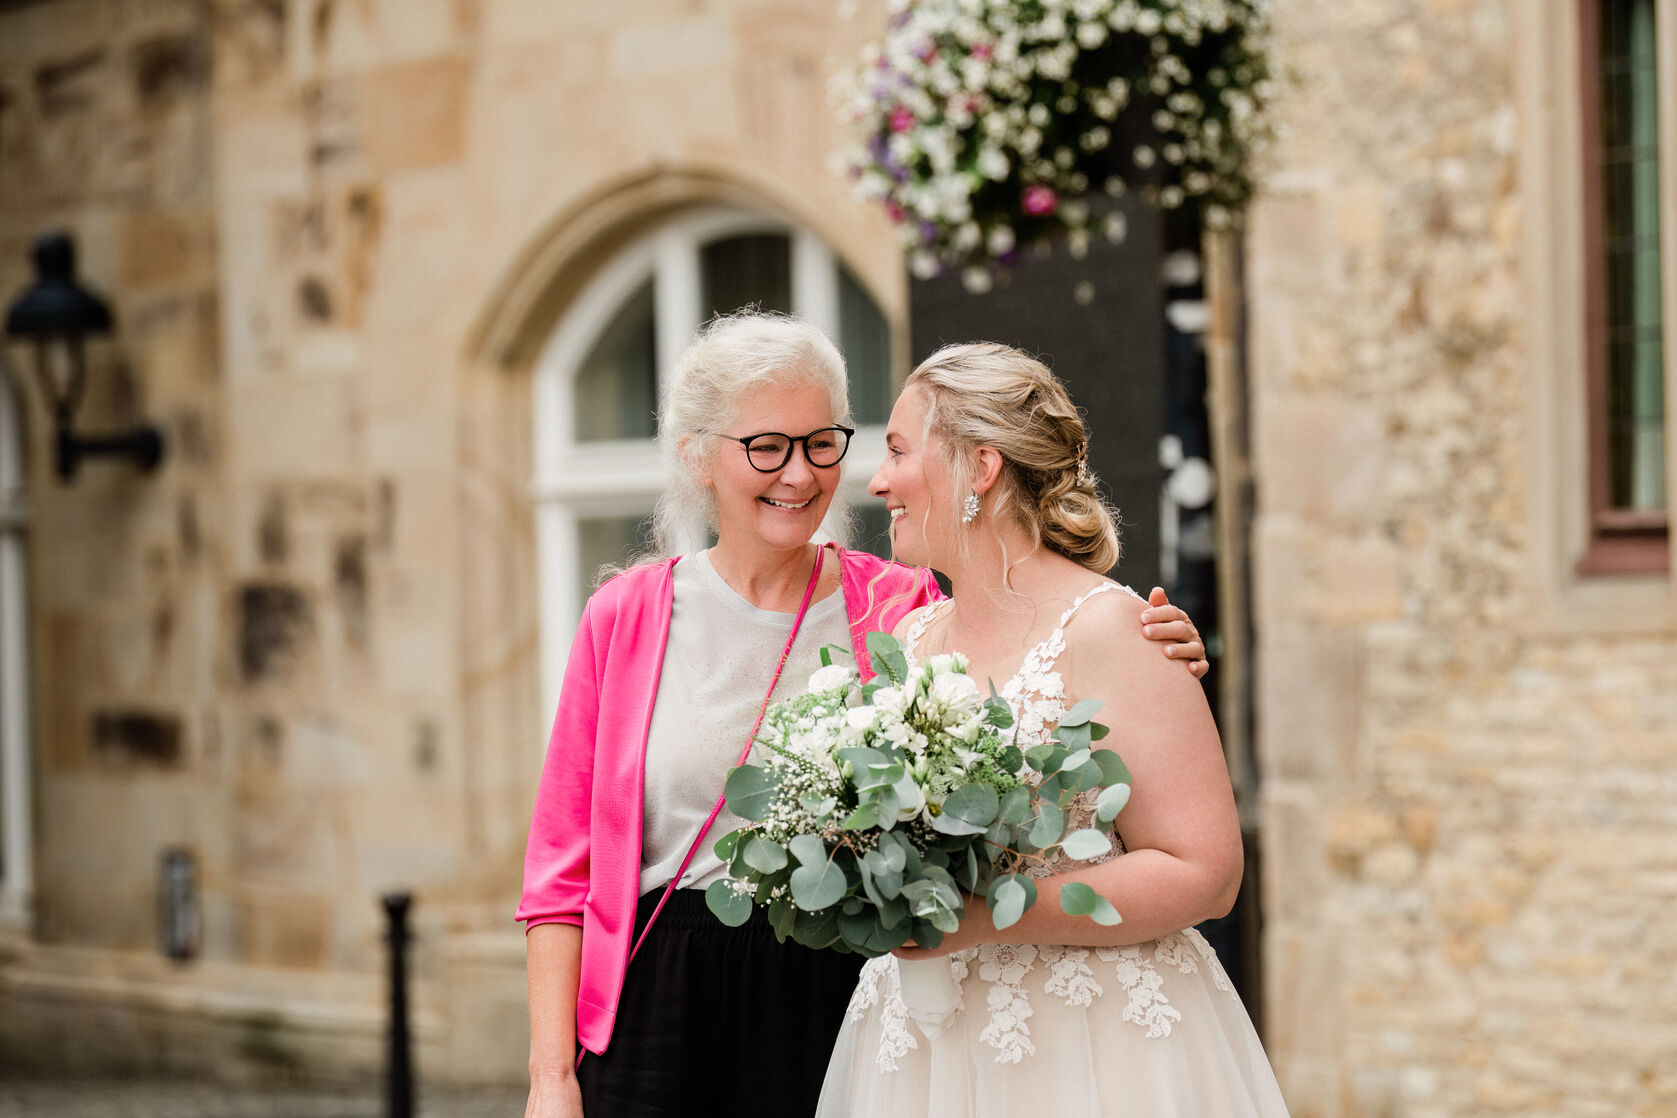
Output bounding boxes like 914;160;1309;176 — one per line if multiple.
706;382;852;551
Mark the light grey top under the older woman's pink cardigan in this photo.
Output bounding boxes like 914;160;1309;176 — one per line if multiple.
641;551;855;893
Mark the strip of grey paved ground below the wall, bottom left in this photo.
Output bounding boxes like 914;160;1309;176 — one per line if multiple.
0;1079;525;1118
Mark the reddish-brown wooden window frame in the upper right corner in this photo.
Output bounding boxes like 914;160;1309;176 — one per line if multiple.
1576;0;1674;575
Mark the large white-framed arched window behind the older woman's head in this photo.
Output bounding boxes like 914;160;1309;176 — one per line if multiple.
533;208;892;709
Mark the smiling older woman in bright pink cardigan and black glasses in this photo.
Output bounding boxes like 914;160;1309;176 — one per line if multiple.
518;313;1201;1118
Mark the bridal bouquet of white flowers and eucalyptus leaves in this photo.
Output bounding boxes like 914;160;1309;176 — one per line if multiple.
706;634;1130;957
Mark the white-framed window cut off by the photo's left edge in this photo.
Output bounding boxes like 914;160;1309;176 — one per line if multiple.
0;375;34;927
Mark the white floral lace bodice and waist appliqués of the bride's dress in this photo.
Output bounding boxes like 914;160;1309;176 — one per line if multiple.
849;582;1234;1071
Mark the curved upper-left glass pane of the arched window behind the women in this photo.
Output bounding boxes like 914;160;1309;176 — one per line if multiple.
575;280;657;443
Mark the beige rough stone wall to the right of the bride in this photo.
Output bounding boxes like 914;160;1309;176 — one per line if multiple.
1246;0;1677;1118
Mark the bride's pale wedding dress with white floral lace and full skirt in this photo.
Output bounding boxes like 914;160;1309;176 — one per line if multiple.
817;583;1286;1118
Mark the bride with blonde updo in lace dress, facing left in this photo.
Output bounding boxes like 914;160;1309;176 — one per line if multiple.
818;344;1286;1118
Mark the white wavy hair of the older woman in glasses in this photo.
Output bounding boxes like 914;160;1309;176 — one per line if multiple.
647;307;852;558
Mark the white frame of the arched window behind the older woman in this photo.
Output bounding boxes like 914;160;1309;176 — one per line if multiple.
532;206;885;712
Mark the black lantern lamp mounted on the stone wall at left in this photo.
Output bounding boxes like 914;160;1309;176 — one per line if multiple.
5;233;163;481
